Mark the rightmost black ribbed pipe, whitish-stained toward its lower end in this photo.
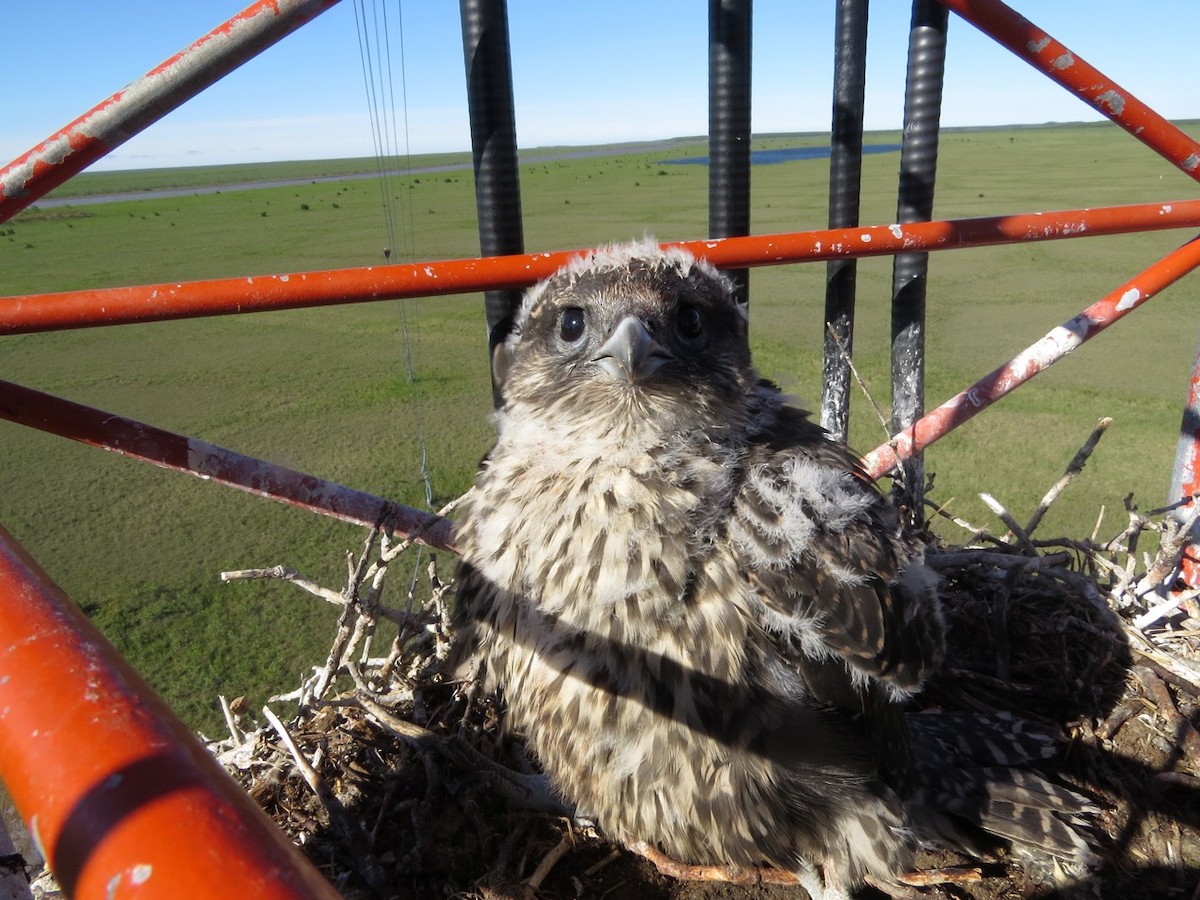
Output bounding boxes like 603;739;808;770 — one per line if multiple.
892;0;949;523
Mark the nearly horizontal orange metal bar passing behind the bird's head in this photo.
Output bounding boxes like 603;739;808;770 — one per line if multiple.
0;200;1200;335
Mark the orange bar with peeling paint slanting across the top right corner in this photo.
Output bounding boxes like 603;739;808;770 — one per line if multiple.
938;0;1200;180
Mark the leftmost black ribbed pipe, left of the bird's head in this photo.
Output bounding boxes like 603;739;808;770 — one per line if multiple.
458;0;524;400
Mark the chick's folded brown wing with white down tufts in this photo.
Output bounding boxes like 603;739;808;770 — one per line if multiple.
731;408;943;702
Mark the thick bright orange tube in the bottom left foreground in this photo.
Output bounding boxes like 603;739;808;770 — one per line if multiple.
0;528;337;900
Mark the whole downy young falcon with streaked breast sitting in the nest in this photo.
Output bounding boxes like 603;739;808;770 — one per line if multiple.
456;241;1088;894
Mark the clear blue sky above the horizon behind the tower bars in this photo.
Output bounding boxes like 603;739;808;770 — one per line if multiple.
0;0;1200;169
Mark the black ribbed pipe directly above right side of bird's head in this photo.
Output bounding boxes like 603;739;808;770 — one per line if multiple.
708;0;751;302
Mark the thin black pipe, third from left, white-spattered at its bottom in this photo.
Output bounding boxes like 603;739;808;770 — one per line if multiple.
821;0;869;443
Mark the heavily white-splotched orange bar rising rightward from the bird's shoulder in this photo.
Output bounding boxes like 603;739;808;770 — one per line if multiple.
863;238;1200;479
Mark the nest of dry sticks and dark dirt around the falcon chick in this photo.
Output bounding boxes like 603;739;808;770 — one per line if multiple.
30;422;1200;900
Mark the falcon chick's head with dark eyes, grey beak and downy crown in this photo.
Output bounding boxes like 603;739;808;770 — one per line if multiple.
493;240;756;439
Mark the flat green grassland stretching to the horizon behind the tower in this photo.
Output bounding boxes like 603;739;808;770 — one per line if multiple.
0;125;1200;731
